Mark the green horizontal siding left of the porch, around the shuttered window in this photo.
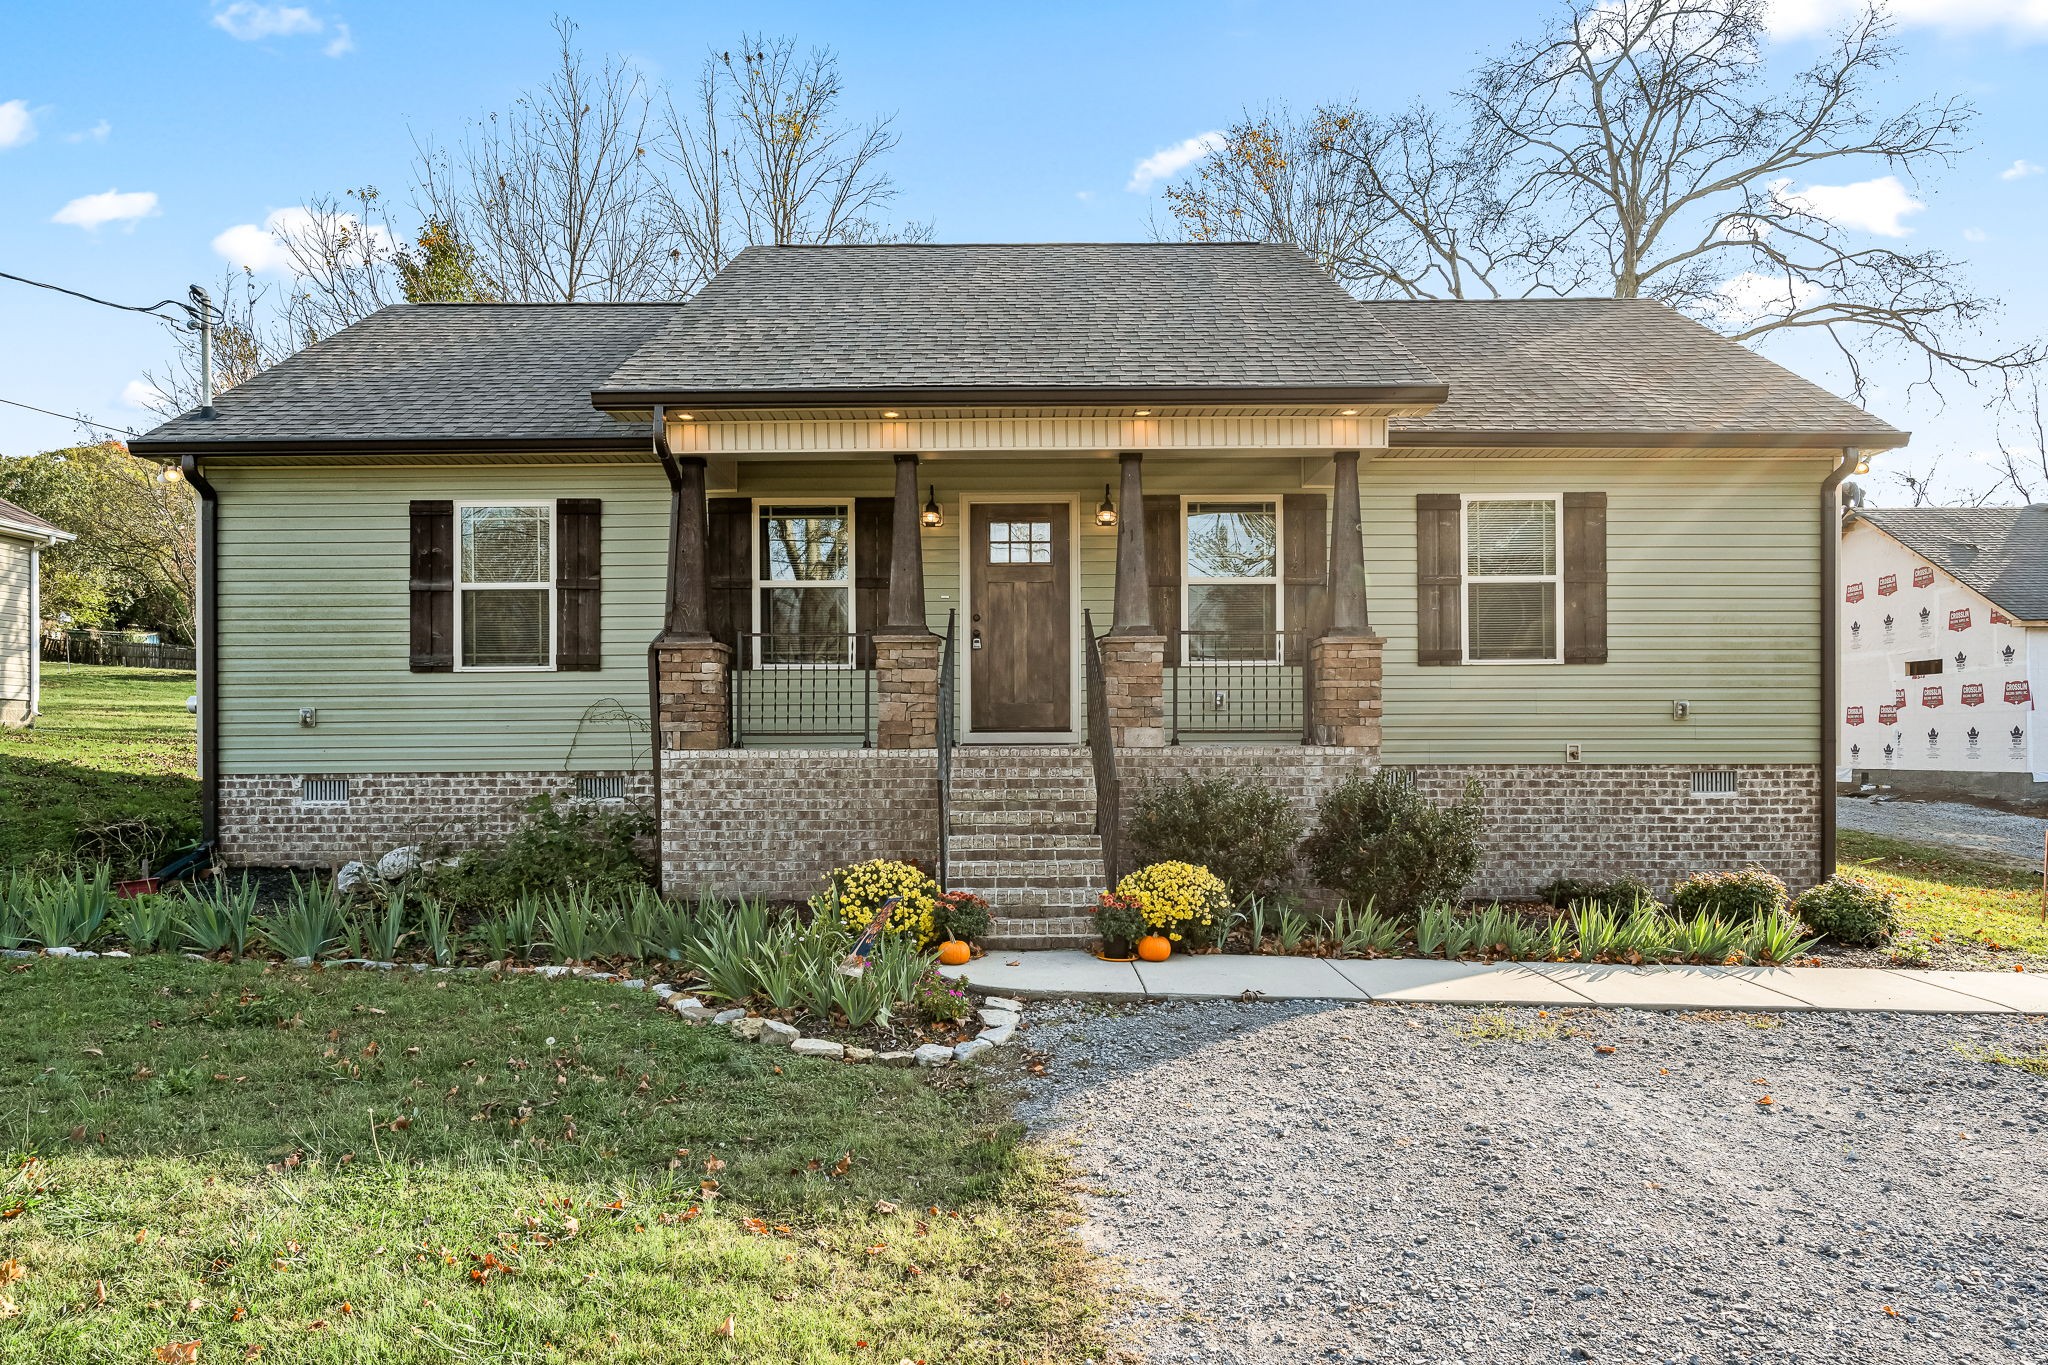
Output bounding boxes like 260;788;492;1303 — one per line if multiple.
207;463;668;774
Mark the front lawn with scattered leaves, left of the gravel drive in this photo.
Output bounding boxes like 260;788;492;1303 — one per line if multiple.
0;958;1104;1365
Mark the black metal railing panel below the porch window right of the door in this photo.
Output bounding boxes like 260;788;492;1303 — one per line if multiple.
1165;630;1311;745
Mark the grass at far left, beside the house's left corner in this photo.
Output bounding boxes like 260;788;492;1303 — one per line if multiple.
0;663;199;876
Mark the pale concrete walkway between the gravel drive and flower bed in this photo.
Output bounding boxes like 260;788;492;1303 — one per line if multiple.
942;950;2048;1015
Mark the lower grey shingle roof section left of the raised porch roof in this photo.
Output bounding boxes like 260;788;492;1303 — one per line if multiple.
131;303;676;454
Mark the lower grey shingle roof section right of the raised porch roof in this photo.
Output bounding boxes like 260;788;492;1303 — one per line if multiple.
1364;299;1907;448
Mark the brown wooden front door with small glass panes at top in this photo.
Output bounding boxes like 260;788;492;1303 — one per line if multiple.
967;503;1073;733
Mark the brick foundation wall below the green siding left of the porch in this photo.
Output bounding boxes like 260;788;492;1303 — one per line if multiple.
219;772;653;868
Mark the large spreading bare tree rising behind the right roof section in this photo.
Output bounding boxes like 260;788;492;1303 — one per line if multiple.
1167;0;2042;397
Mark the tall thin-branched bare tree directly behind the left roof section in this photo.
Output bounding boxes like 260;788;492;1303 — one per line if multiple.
416;18;678;303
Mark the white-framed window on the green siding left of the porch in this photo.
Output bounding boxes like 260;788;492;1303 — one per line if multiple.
455;503;555;669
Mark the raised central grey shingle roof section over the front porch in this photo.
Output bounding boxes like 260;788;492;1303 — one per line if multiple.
596;241;1442;405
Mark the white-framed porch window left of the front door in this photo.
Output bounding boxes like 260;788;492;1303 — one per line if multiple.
754;503;854;667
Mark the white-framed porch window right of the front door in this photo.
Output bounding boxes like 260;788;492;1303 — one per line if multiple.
1182;499;1280;663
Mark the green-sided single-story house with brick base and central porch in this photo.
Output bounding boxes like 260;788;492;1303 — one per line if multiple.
133;244;1905;943
